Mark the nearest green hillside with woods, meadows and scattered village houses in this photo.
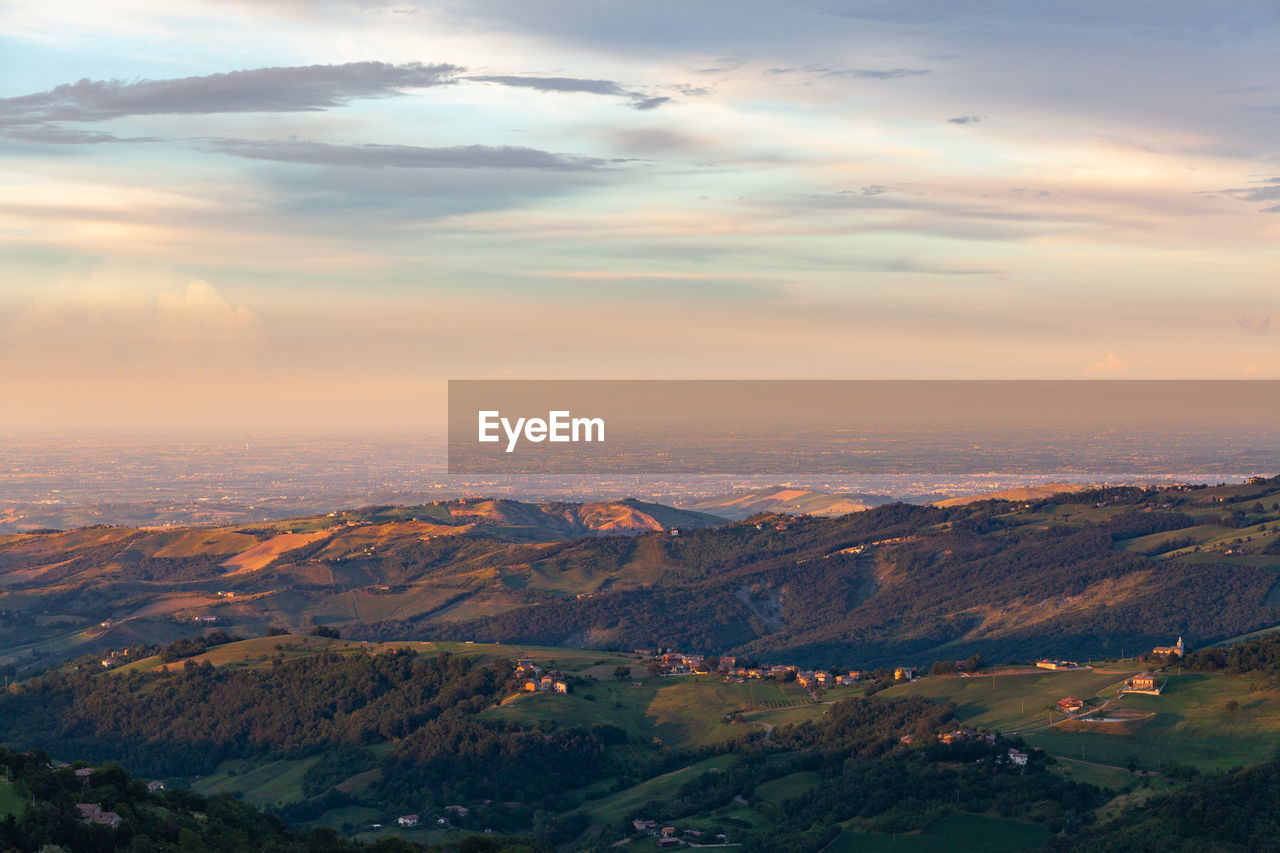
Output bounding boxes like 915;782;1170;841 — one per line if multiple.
0;634;1280;853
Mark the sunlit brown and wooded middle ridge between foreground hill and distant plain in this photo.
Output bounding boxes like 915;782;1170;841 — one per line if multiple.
0;479;1280;669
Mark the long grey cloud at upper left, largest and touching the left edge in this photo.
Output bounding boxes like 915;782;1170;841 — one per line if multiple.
0;61;465;127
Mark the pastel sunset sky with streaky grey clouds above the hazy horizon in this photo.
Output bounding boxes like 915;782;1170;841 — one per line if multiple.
0;0;1280;430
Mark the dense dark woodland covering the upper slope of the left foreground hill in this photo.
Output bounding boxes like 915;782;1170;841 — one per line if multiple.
0;651;509;776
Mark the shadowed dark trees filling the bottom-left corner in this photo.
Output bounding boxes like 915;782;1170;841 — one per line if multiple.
0;749;552;853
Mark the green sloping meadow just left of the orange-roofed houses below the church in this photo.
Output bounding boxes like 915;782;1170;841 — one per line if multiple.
879;670;1137;733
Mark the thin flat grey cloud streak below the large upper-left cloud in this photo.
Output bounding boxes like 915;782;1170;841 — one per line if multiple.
205;140;607;172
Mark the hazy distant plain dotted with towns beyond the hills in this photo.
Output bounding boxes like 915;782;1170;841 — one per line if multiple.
0;429;1280;533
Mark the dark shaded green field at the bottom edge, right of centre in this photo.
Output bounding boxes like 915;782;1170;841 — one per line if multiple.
827;812;1048;853
